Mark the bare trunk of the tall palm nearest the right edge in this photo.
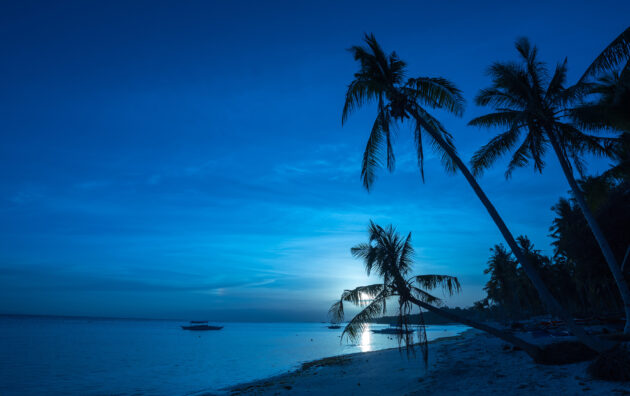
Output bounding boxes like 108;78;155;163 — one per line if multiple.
549;133;630;334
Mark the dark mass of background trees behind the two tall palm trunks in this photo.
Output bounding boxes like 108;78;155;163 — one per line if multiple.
475;176;630;321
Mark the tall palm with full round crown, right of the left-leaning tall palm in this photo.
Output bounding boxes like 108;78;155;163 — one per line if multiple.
469;38;630;333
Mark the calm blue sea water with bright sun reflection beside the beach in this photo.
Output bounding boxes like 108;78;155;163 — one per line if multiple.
0;316;466;395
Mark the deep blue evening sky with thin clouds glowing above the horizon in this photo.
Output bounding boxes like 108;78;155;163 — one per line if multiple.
0;1;630;321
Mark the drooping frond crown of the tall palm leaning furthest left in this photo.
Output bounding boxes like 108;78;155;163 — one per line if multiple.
342;34;464;190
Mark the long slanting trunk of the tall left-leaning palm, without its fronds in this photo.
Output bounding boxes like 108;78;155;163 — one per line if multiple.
411;105;612;352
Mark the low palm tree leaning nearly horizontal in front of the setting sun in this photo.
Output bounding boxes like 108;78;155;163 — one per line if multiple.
329;221;540;362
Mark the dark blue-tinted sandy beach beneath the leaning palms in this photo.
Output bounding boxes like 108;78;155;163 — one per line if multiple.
227;331;630;396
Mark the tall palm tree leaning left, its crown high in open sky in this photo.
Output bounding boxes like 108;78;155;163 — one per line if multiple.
342;34;606;351
